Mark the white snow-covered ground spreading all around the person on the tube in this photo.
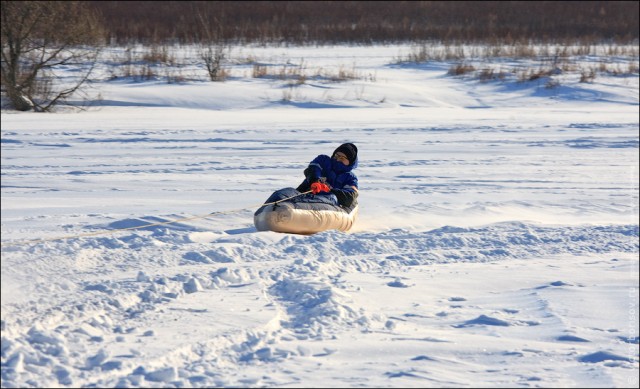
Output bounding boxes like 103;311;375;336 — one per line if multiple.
1;46;639;387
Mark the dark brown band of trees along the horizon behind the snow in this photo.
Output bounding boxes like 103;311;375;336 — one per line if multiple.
91;1;639;45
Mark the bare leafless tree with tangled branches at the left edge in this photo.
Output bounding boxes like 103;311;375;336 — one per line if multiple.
0;0;101;111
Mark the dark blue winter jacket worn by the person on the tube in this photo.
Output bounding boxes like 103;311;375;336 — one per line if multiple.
297;154;358;208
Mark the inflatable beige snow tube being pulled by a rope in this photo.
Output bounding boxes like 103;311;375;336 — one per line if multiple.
253;188;358;235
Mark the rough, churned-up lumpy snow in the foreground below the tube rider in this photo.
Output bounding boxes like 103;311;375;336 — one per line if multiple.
2;222;638;386
